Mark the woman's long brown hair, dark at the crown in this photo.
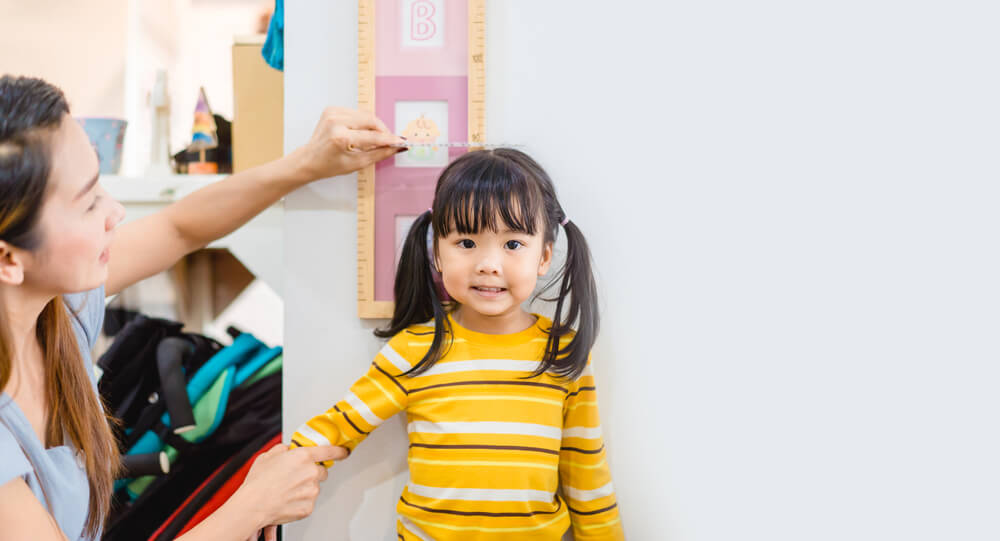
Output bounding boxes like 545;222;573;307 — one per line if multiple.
0;75;119;538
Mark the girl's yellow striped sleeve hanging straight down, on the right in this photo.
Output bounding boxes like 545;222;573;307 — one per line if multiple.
559;361;625;541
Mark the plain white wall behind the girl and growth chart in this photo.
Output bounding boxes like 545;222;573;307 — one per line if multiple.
284;0;1000;541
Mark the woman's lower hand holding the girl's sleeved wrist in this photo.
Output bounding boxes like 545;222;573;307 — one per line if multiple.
232;443;347;539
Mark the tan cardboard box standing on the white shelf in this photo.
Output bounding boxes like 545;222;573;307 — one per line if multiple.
233;34;285;173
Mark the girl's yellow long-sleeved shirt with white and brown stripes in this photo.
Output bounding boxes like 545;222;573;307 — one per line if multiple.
292;316;624;541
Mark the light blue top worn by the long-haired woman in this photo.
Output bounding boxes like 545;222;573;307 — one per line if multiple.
0;287;104;541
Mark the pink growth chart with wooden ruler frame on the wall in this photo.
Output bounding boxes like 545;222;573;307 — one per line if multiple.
358;0;485;318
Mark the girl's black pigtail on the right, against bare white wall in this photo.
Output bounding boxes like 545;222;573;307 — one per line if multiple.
534;217;601;380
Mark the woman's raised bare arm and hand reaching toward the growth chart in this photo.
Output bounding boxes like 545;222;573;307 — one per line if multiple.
105;108;402;295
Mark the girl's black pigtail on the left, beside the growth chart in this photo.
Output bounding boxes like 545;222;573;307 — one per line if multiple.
375;210;450;376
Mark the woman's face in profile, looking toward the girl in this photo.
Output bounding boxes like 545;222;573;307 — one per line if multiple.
23;115;125;295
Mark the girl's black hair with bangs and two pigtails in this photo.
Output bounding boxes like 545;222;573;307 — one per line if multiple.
375;148;600;380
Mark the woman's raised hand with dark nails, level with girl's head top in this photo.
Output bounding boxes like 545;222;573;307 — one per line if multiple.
286;107;403;182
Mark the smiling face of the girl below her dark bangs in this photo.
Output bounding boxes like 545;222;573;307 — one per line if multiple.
435;220;552;326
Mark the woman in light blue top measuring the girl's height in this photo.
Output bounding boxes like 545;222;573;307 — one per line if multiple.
0;76;401;541
